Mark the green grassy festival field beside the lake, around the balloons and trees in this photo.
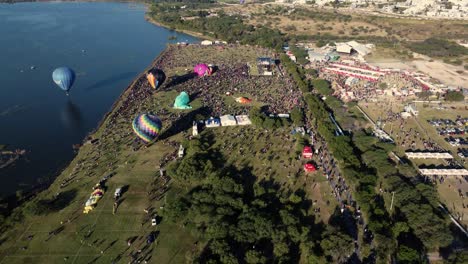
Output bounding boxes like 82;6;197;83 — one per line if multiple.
0;46;336;263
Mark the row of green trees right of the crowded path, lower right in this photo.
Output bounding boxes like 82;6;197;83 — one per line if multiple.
353;131;453;252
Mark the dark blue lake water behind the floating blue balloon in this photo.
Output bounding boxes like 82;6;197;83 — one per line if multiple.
0;3;196;195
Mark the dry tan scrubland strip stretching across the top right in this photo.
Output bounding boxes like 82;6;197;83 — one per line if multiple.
215;3;468;41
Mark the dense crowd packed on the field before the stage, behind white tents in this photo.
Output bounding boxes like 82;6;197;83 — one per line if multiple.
156;47;301;116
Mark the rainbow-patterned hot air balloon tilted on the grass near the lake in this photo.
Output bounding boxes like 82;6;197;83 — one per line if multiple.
132;114;162;143
